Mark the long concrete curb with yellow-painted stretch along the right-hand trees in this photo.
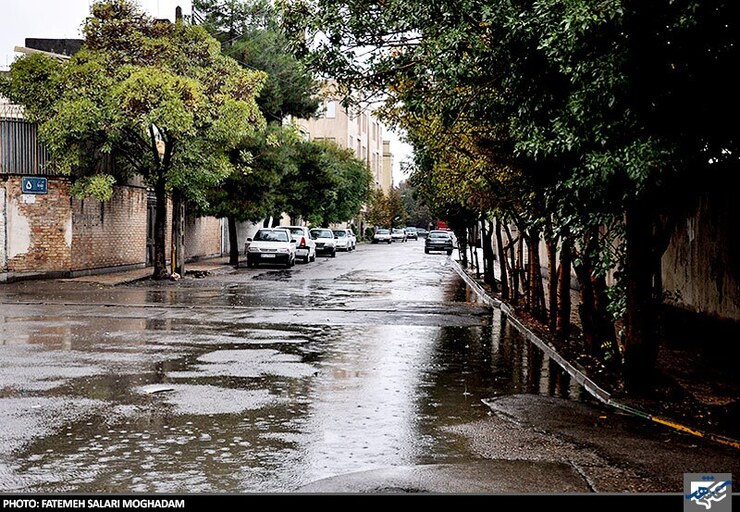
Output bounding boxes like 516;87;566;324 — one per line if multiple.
450;258;740;450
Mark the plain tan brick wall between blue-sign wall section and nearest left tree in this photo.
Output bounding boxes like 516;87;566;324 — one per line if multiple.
71;187;147;271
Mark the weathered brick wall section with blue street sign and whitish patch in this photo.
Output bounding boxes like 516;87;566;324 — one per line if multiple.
5;176;72;274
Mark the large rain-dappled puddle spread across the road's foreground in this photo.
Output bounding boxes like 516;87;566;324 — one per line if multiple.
0;310;579;493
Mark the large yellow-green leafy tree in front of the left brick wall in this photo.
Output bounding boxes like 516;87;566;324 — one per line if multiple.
3;0;265;279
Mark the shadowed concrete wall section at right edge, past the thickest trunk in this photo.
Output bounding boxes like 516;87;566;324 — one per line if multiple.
662;187;740;321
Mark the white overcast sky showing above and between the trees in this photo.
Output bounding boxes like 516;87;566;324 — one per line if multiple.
0;0;411;185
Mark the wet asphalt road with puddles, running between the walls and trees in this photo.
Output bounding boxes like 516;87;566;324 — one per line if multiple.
0;241;740;494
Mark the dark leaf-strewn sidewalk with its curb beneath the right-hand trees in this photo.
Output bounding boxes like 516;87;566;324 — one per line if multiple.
450;262;740;455
